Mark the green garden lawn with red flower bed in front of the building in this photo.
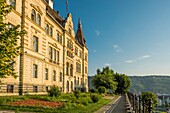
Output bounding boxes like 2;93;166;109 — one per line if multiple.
0;93;115;113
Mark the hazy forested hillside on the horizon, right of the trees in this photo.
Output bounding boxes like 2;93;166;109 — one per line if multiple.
129;76;170;94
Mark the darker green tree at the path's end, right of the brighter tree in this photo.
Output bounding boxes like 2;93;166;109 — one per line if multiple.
114;73;131;94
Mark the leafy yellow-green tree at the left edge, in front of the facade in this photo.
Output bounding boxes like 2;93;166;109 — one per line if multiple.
0;0;25;78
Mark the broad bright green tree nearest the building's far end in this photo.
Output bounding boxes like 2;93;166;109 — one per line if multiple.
92;67;117;92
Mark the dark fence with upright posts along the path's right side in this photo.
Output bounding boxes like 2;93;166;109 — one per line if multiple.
128;93;154;113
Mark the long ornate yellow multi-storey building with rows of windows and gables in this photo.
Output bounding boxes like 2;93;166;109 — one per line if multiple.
0;0;88;95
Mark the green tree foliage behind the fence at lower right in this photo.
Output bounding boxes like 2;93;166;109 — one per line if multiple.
141;92;158;107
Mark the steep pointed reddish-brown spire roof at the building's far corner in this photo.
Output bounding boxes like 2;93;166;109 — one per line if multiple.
76;19;86;47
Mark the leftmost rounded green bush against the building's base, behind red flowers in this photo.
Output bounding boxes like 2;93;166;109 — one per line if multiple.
48;86;61;97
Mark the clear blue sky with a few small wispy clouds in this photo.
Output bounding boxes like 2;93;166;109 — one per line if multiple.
54;0;170;76
